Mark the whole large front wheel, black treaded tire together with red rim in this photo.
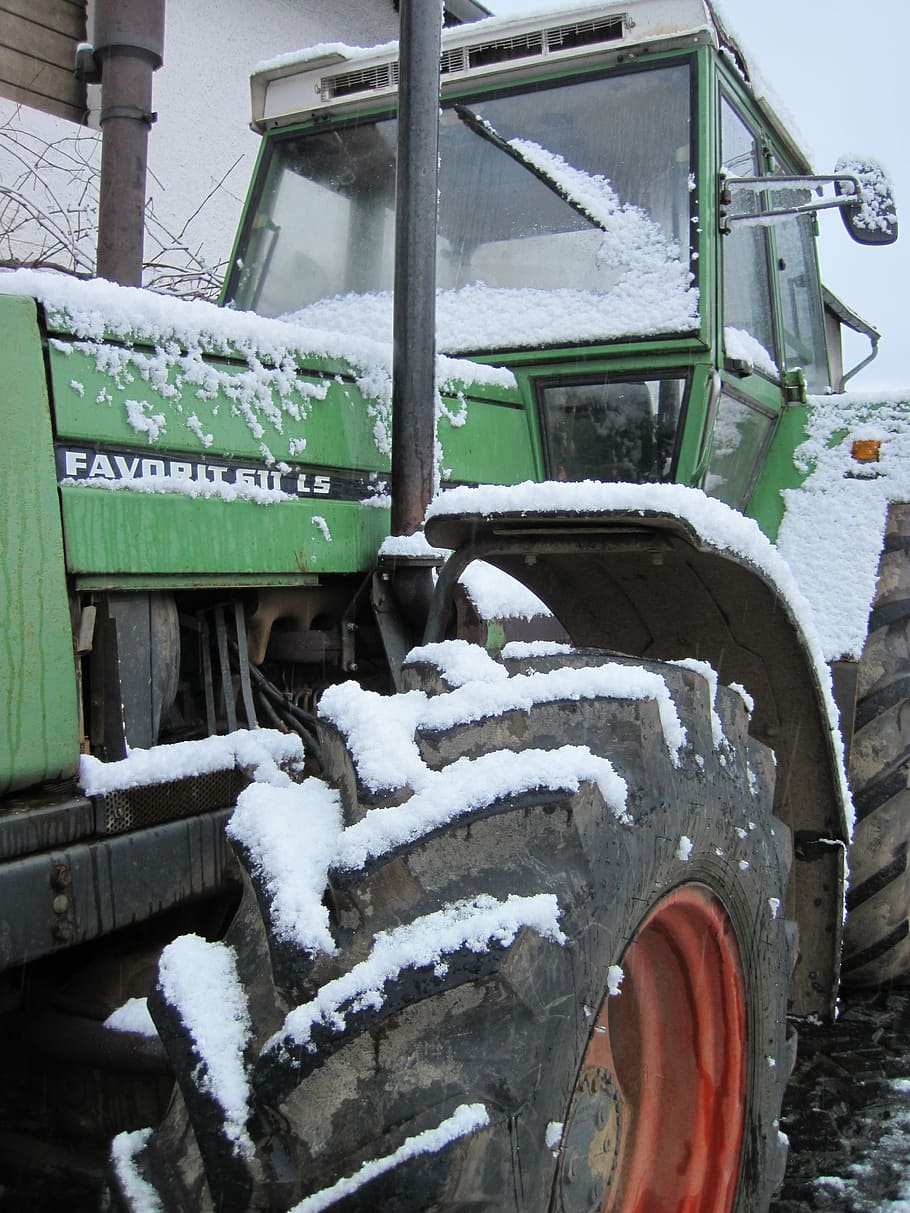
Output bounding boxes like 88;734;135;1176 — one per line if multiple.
114;653;794;1213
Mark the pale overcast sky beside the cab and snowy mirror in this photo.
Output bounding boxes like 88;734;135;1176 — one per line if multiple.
484;0;910;391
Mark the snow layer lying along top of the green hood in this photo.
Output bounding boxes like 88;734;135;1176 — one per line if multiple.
0;269;514;463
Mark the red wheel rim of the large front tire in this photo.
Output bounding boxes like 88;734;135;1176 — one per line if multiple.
558;884;747;1213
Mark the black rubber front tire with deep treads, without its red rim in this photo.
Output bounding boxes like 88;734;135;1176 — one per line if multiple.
113;653;795;1213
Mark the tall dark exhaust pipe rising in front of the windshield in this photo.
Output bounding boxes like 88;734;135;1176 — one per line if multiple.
392;0;443;535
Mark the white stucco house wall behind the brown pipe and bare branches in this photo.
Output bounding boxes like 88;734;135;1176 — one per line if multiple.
0;0;398;281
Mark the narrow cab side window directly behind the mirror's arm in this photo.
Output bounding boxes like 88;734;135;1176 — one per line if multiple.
721;99;779;376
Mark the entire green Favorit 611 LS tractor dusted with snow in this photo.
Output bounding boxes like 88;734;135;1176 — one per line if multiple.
0;0;910;1213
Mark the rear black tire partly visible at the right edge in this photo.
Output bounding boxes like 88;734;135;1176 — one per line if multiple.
843;503;910;986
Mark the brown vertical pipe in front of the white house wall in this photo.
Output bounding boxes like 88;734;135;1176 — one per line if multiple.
93;0;165;286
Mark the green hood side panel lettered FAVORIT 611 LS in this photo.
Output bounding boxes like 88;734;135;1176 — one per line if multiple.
49;326;535;587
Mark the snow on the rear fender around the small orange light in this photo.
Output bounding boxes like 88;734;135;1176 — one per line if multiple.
778;392;910;661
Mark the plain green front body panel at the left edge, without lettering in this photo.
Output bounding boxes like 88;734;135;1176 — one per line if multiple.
0;297;79;791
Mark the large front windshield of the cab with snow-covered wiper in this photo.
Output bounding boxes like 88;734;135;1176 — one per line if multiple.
231;63;698;352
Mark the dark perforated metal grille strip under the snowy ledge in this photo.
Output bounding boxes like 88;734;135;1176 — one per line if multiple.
97;769;250;835
